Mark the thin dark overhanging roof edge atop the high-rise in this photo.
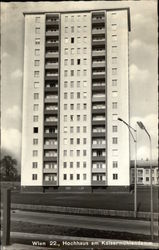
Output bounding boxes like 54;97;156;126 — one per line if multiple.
23;7;131;31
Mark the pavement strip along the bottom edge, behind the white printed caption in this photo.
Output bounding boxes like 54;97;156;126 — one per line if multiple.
2;232;159;250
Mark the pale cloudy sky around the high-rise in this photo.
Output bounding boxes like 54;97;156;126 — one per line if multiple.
1;0;158;170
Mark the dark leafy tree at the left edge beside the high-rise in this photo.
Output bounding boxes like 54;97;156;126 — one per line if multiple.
1;155;18;181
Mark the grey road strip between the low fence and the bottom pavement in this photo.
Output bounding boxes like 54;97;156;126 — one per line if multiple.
11;210;157;235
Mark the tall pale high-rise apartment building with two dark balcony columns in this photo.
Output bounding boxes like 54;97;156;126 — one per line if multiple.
21;8;130;190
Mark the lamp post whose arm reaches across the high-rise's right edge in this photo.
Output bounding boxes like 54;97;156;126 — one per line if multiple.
118;118;137;218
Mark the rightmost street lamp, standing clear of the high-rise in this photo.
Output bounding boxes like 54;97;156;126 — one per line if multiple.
137;121;154;240
